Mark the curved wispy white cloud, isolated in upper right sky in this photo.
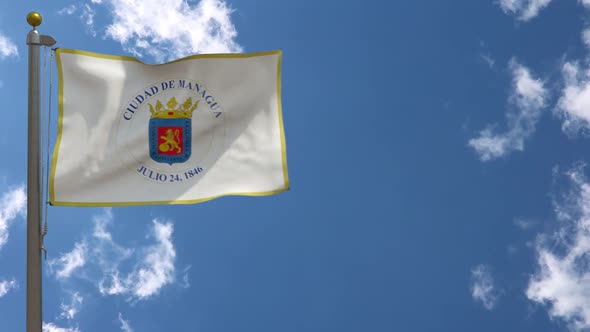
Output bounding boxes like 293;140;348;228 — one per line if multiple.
469;60;547;161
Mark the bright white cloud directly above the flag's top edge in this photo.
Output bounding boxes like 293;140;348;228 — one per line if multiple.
86;0;242;61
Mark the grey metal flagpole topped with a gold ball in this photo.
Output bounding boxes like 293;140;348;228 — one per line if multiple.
27;12;55;332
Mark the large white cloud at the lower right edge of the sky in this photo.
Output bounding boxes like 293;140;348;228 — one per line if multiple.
526;166;590;331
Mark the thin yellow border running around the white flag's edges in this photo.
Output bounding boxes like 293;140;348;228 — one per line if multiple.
49;48;289;207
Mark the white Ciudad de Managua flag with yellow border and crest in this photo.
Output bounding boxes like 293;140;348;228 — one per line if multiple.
50;49;289;206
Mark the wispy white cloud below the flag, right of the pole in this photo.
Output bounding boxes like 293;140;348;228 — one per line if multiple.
49;209;179;300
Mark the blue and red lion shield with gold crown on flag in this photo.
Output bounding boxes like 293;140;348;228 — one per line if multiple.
148;97;199;165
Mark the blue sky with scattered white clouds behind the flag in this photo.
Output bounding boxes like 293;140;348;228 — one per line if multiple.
0;0;590;332
